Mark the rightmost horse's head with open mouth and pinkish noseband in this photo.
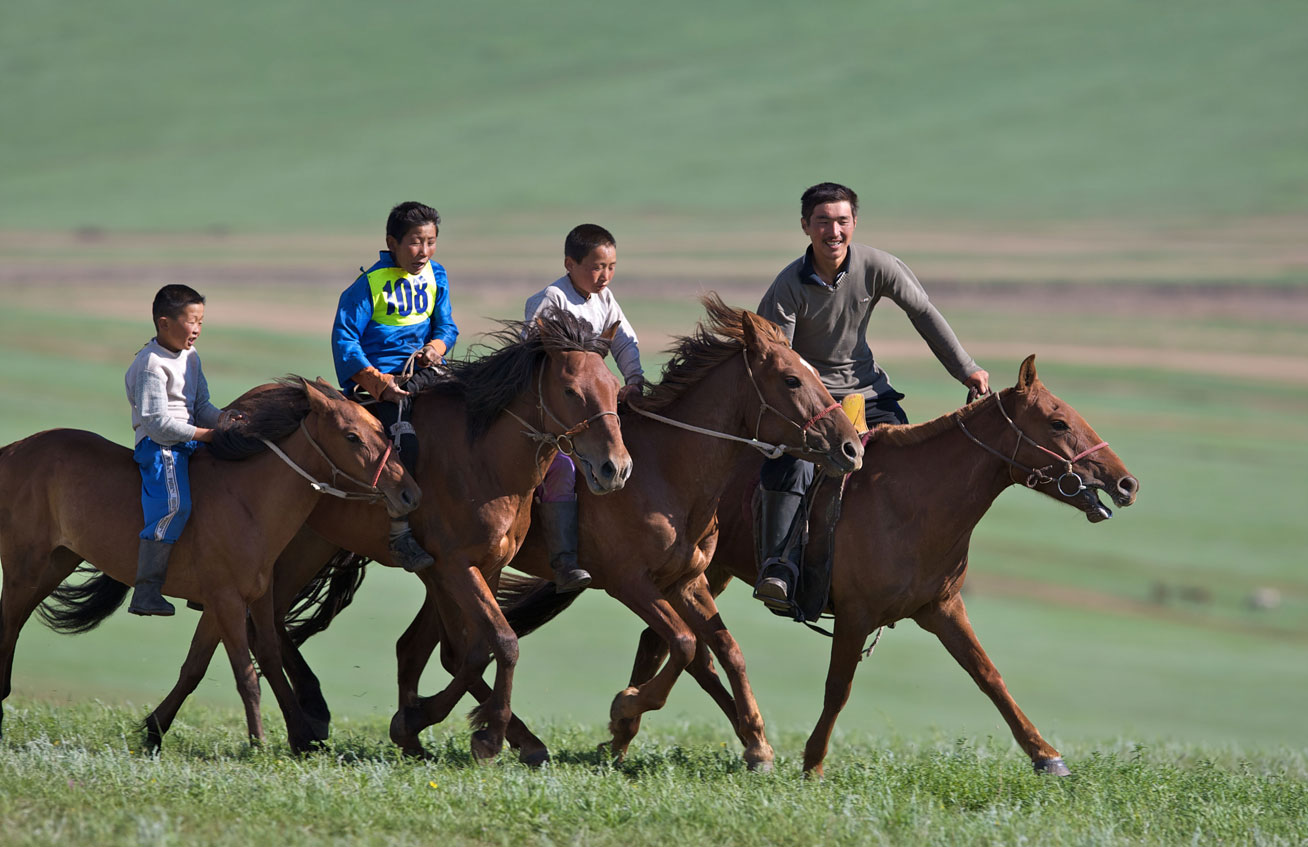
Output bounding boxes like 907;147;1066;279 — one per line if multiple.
999;356;1139;523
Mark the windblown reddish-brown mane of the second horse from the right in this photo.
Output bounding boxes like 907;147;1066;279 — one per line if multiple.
637;291;790;412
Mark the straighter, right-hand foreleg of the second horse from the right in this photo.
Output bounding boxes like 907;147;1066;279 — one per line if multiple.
680;575;773;771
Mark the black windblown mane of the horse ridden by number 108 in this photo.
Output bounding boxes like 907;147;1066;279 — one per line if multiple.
425;305;610;442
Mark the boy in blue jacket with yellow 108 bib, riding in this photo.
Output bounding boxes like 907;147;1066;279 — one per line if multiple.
331;201;459;570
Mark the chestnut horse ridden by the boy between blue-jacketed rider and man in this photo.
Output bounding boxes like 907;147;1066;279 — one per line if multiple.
288;295;862;770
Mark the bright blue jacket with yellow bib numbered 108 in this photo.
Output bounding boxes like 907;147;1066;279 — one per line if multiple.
331;250;459;390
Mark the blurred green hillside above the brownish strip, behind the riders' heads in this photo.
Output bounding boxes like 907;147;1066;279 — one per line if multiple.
0;0;1308;231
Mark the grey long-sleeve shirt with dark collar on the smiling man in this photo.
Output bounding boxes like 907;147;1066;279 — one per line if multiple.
759;244;981;400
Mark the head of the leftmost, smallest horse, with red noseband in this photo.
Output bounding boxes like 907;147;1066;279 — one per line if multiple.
297;378;422;518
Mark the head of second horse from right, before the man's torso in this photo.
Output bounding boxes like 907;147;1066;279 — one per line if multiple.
742;301;863;474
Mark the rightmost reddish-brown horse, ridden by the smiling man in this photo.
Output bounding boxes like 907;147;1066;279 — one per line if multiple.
612;356;1139;776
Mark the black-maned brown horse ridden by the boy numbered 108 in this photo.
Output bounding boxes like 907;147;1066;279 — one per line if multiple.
66;311;632;759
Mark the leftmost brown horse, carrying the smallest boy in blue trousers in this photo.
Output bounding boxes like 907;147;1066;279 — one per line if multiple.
0;378;421;750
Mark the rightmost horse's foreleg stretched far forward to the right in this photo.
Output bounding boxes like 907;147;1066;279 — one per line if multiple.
913;595;1071;776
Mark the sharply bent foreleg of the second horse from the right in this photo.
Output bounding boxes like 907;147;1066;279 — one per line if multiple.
608;579;696;759
